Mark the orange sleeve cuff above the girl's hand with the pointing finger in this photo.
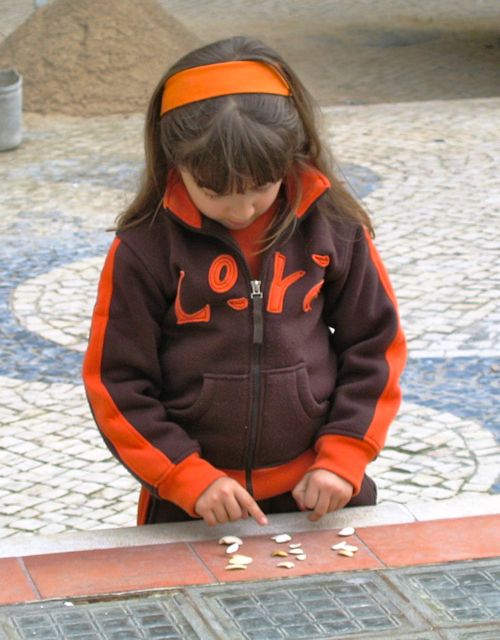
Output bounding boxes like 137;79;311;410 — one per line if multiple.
158;453;226;518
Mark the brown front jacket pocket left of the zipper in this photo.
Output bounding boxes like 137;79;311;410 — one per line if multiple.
168;373;249;469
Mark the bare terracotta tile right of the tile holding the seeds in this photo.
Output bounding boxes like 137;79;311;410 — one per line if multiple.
357;515;500;567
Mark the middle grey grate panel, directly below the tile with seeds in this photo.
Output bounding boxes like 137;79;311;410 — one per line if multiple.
191;572;433;640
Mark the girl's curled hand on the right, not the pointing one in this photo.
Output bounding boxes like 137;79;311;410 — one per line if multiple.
292;469;354;522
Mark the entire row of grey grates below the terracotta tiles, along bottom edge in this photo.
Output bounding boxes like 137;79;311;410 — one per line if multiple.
0;559;500;640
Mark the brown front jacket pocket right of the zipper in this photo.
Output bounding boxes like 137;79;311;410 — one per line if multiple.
255;364;330;467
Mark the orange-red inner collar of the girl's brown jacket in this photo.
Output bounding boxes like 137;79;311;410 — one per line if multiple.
163;166;330;229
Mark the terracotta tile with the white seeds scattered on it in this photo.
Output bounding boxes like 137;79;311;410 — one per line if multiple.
192;531;383;582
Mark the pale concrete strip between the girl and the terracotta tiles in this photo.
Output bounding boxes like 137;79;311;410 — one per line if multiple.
0;494;500;558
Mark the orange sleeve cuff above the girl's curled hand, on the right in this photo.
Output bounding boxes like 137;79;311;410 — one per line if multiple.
308;435;377;495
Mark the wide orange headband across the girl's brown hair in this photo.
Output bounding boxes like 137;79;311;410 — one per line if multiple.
160;60;292;115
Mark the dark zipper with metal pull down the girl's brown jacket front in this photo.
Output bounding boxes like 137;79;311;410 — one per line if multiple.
245;280;264;496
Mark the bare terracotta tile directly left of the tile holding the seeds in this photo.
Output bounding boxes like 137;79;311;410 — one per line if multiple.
25;543;214;598
